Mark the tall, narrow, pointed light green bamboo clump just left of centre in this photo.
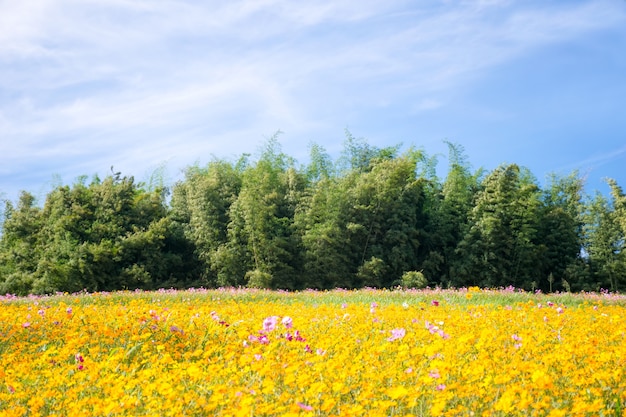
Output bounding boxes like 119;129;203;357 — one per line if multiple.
216;135;305;289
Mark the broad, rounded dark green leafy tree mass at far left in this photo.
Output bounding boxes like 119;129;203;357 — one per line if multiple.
2;174;195;293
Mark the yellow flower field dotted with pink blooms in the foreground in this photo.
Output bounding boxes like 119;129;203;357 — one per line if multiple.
0;288;626;416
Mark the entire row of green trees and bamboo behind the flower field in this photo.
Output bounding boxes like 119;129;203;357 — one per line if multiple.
0;133;626;295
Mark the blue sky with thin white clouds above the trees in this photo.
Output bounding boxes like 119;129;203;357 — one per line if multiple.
0;0;626;200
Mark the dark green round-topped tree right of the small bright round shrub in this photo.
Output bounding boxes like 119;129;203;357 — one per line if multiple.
458;164;540;289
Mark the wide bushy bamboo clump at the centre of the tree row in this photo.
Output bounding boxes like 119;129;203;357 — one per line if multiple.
295;147;424;288
